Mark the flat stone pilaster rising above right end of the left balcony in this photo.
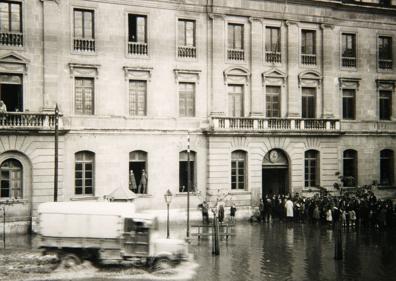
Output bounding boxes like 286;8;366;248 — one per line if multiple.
41;0;60;111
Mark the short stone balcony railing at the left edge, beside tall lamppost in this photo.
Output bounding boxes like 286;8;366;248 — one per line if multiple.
0;112;61;131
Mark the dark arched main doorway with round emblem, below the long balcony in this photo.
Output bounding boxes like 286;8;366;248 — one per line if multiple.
261;149;289;196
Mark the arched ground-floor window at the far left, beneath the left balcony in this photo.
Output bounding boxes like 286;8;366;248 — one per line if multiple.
0;159;23;198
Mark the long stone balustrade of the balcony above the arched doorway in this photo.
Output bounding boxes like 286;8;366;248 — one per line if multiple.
212;117;340;132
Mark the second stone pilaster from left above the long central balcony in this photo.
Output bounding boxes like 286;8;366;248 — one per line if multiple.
249;18;265;116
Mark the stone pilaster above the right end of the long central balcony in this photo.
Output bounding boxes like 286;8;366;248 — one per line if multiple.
320;24;339;118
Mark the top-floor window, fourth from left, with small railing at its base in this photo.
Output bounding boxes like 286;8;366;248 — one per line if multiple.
177;19;197;58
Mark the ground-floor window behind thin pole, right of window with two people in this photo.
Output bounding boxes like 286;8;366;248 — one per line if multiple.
179;151;196;192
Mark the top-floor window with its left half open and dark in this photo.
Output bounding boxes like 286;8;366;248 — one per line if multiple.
128;14;148;55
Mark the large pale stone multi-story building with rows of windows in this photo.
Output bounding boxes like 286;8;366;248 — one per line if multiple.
0;0;396;231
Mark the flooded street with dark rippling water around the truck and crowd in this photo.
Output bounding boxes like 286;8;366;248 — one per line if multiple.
0;222;396;281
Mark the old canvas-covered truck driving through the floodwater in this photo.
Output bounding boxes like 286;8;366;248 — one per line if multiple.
38;201;188;269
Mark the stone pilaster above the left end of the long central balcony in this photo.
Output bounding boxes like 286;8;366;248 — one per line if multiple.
209;14;227;116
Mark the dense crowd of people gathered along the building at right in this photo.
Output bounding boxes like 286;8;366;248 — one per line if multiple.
251;190;396;229
